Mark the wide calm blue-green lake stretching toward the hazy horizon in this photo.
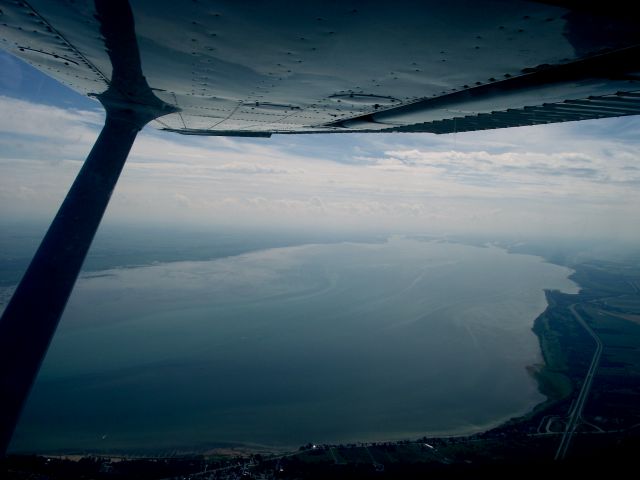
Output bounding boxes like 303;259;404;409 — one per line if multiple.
12;237;577;452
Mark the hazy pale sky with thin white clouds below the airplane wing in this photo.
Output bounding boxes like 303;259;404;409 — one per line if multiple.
0;53;640;240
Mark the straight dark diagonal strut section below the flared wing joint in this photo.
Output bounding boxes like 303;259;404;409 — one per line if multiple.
0;106;139;452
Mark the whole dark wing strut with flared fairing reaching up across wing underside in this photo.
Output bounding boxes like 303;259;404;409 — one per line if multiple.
0;0;176;456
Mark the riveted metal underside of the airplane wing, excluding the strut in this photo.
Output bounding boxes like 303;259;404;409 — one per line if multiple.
0;0;640;136
